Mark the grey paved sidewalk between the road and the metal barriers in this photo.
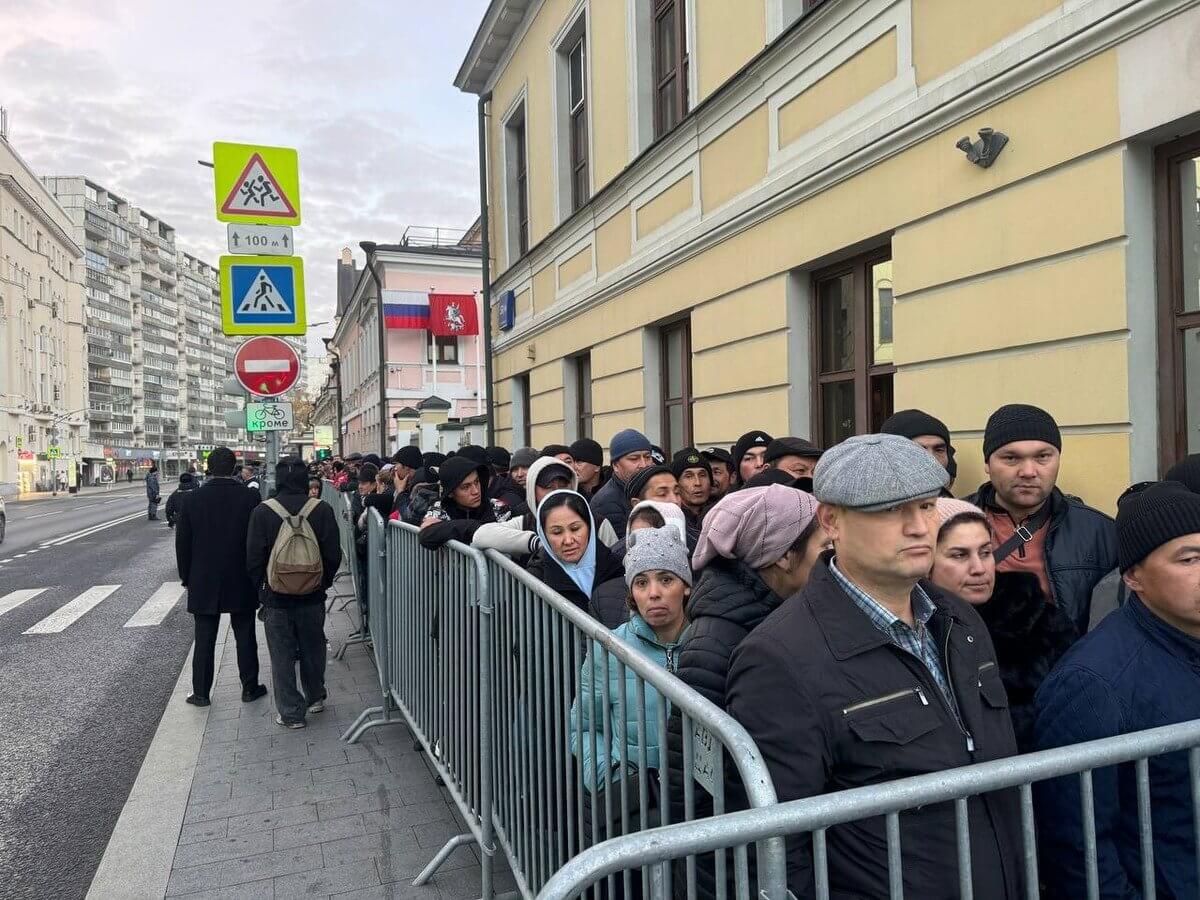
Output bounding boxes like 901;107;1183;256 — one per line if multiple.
94;581;514;900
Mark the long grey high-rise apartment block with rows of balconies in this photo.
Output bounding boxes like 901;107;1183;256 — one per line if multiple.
43;175;250;482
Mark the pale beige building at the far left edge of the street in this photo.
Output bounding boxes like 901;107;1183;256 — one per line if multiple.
0;132;86;496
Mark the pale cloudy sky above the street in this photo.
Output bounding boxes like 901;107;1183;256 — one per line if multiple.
0;0;487;360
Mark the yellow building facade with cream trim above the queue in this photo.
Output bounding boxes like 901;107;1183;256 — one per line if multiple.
457;0;1200;510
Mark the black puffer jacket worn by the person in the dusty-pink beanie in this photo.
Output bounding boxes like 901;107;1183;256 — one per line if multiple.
667;557;784;900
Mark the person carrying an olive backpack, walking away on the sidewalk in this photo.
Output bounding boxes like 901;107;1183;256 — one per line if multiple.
246;456;342;728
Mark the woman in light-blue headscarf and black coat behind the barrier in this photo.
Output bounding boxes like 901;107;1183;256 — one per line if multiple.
526;491;629;629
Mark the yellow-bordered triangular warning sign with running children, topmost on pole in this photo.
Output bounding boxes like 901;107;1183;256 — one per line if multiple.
212;140;300;224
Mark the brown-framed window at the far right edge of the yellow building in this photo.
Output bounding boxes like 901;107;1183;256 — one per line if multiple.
1157;133;1200;470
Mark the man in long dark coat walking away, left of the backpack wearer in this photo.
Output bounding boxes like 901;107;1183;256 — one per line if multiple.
175;446;266;707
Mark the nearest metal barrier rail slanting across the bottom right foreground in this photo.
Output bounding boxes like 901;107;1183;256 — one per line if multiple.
539;720;1200;900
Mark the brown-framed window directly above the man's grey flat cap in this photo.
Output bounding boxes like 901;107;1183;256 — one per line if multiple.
812;248;895;446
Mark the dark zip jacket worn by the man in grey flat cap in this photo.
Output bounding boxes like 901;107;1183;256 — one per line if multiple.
727;553;1022;900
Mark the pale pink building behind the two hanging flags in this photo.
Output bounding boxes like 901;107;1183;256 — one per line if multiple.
326;227;487;454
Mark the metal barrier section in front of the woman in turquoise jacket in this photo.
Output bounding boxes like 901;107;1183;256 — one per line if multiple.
482;551;786;900
